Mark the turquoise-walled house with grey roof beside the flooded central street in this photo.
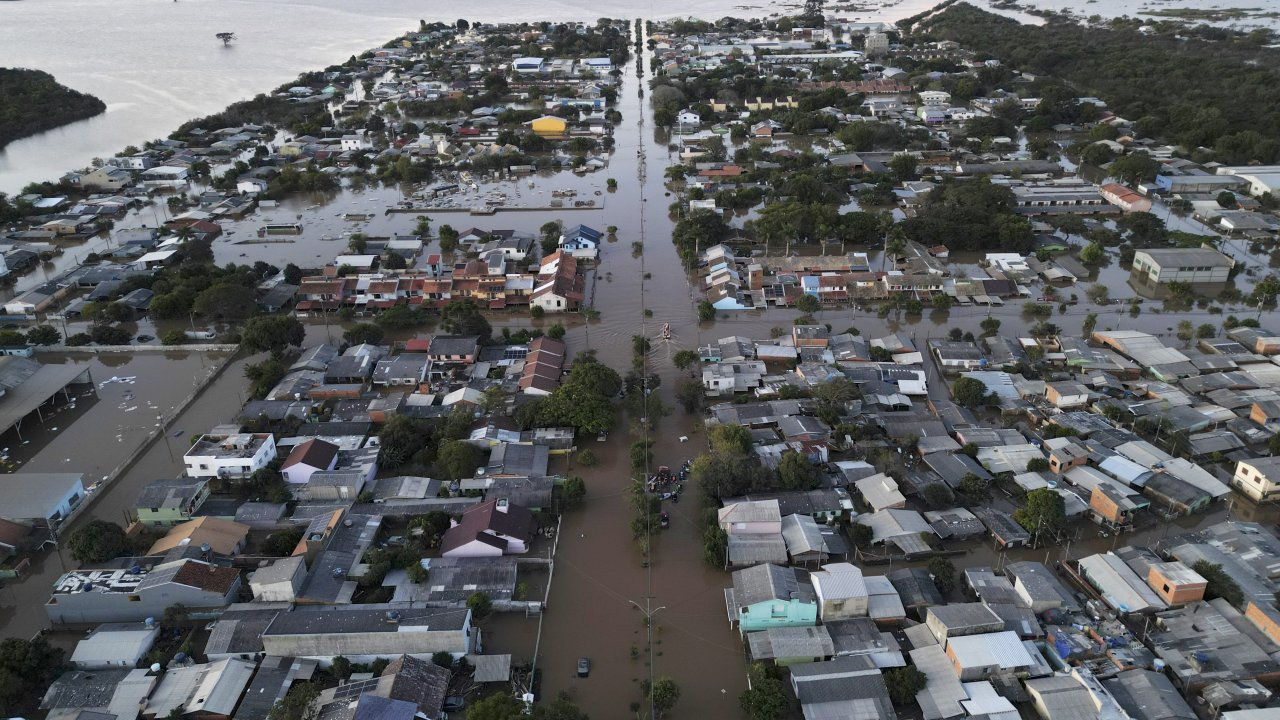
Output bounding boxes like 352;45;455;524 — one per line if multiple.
724;565;818;633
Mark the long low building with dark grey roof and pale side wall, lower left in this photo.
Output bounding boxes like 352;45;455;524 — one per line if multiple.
262;603;475;667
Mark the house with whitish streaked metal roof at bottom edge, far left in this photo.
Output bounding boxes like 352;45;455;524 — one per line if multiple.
141;657;257;720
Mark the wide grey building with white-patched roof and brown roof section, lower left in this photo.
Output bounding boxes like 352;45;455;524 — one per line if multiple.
45;560;241;625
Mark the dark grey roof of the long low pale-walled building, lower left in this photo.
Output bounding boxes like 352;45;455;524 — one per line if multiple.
262;603;470;635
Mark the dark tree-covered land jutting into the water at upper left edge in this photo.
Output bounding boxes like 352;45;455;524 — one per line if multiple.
0;68;106;147
